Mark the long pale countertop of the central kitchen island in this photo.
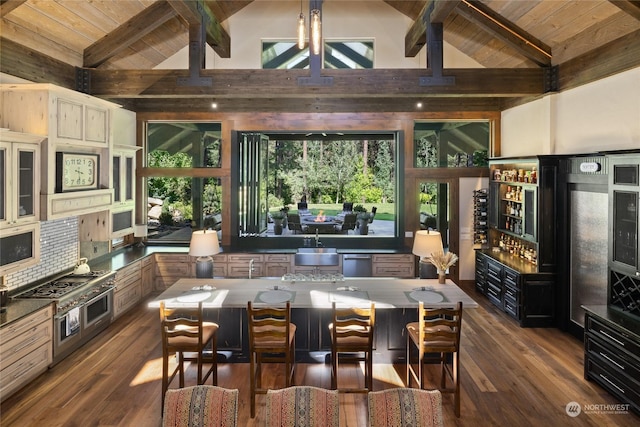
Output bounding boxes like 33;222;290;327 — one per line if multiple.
148;277;478;308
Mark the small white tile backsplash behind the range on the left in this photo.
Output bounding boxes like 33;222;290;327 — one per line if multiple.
6;217;79;291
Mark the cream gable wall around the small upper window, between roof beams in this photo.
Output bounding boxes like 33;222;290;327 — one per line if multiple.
156;0;481;69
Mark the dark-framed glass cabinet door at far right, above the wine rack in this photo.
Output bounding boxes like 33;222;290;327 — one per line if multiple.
610;158;640;274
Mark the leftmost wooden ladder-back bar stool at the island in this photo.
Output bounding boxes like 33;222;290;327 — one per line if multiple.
160;301;218;407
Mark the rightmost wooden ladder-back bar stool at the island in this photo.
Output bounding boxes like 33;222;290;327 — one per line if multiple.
407;301;462;417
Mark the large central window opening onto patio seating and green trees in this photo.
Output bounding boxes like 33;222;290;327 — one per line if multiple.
231;132;402;245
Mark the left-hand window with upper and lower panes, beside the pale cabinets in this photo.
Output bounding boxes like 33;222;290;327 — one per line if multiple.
146;122;222;242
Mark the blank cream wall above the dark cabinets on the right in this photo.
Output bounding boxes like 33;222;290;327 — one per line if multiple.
502;67;640;157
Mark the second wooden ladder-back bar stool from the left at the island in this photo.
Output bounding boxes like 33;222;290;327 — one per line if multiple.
247;301;296;418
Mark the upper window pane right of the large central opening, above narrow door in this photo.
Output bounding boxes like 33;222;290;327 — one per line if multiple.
414;121;491;168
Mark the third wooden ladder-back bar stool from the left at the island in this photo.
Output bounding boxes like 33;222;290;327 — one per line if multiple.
329;302;376;393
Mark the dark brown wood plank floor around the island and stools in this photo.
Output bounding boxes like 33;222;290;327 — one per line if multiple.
0;286;640;427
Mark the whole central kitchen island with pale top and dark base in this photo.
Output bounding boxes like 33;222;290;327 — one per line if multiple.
148;277;478;363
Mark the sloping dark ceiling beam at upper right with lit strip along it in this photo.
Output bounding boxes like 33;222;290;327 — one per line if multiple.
456;0;551;67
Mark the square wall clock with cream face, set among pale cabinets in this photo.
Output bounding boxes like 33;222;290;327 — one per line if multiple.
56;152;100;193
